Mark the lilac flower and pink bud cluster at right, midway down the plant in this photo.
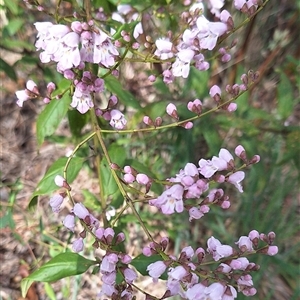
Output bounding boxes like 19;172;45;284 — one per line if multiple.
149;145;260;220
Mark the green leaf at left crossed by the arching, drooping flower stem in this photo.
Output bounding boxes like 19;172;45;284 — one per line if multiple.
29;157;85;207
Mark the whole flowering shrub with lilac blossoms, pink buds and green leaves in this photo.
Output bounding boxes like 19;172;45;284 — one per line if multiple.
11;0;284;300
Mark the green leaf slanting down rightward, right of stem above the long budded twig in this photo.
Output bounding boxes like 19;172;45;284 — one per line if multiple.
104;75;141;109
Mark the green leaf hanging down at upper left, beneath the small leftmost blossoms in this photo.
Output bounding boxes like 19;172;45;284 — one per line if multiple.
36;89;70;146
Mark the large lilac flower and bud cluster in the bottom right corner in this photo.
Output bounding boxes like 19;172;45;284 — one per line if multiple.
143;230;278;300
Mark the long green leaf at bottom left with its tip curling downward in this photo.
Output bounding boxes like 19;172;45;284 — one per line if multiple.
21;252;99;297
